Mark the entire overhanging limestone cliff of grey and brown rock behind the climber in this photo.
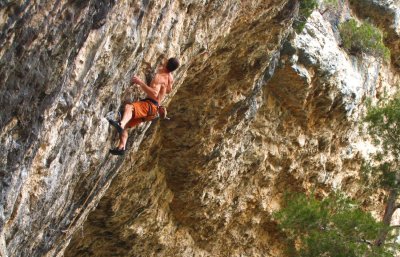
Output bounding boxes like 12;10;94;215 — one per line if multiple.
0;0;398;256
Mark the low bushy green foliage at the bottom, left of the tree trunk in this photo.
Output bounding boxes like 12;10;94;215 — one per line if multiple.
274;191;393;257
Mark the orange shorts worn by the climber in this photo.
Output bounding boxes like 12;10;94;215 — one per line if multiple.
126;100;158;128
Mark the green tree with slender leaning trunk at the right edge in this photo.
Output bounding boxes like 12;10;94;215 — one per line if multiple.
363;97;400;246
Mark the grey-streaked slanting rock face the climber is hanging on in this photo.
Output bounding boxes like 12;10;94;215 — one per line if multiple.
0;1;244;256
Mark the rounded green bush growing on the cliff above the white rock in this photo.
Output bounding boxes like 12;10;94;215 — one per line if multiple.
339;19;390;60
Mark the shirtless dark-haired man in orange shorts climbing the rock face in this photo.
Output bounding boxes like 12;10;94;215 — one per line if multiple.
108;58;179;155
